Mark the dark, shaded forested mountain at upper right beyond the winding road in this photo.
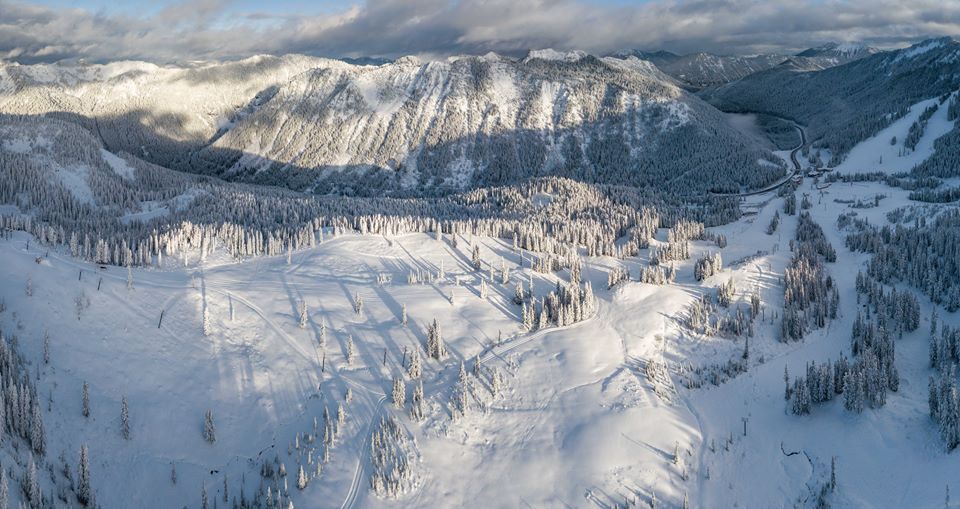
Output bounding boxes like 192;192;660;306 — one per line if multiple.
702;38;960;162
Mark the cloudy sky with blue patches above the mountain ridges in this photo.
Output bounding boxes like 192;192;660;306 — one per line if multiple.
0;0;960;63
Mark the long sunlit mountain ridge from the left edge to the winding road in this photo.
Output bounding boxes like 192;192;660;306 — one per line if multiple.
0;50;784;195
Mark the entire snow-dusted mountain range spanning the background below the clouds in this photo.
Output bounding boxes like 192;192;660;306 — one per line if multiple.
0;38;960;196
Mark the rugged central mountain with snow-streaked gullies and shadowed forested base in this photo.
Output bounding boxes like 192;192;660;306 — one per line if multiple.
198;51;782;193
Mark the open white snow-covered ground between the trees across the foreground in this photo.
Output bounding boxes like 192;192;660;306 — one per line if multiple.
0;145;960;508
